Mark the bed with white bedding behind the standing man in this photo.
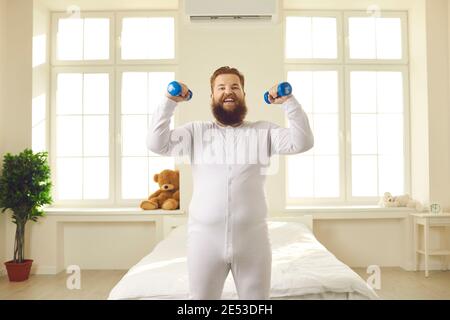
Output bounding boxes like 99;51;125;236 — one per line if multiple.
108;216;378;300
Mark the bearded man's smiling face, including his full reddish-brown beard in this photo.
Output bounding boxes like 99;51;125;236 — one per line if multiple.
211;74;247;126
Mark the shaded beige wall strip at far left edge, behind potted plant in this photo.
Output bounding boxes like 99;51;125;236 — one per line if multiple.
0;0;33;274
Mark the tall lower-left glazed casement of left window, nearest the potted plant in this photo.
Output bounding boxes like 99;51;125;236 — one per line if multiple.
54;71;111;200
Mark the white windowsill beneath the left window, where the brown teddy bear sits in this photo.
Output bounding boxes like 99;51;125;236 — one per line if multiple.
44;208;185;216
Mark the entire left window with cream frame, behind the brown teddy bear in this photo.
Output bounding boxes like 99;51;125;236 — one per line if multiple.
49;12;176;206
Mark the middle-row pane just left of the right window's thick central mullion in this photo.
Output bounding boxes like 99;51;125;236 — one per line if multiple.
313;115;339;155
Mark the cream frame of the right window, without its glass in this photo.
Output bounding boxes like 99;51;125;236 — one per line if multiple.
283;10;411;207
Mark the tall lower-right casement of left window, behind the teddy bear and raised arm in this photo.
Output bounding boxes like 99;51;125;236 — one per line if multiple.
120;71;175;199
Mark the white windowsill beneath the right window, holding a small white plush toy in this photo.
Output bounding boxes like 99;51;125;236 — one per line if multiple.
284;206;418;220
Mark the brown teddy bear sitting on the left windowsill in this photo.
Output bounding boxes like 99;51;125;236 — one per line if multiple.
141;170;180;210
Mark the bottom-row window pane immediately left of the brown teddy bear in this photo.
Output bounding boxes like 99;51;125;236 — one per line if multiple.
122;157;149;200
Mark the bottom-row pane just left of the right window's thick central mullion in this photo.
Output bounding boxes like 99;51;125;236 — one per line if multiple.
314;156;339;198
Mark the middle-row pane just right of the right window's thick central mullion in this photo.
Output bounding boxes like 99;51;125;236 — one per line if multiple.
352;114;377;154
